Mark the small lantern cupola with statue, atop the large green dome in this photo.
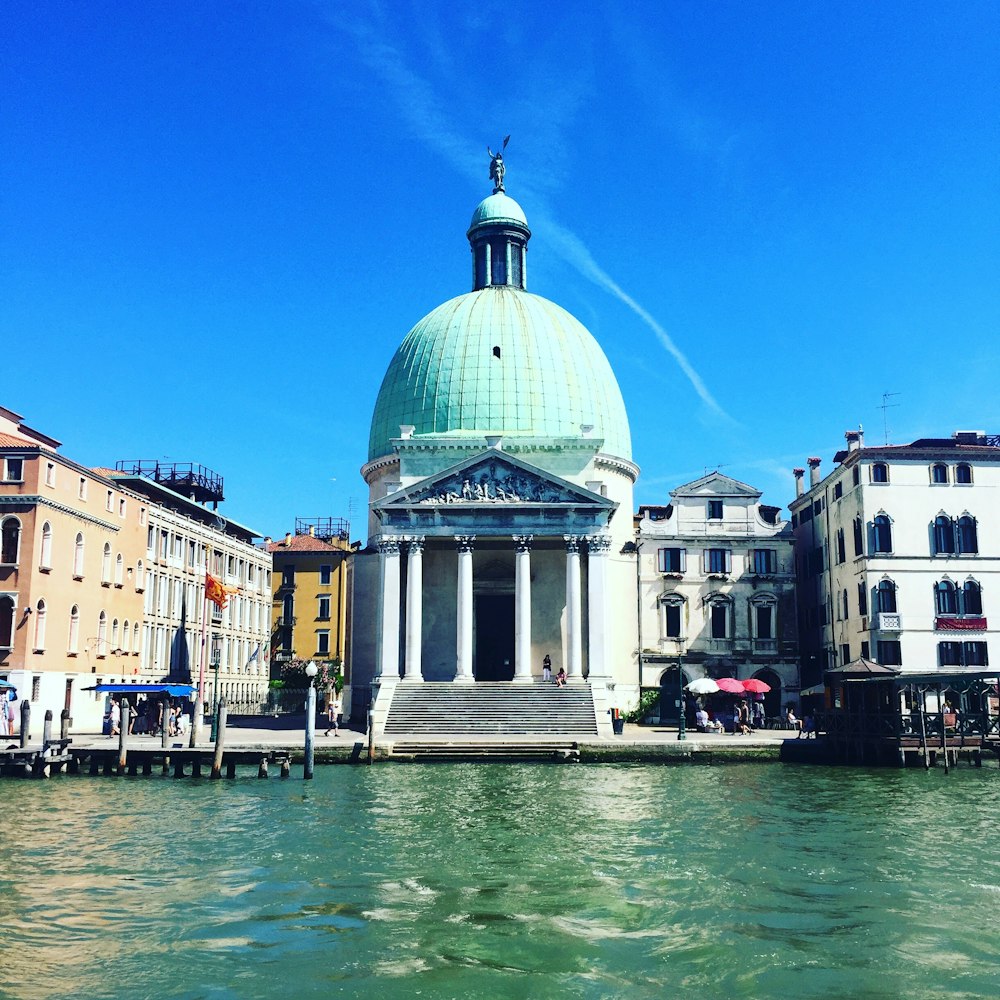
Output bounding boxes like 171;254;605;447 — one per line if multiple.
466;136;531;292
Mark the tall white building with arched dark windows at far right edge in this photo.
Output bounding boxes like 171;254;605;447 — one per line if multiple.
789;431;1000;685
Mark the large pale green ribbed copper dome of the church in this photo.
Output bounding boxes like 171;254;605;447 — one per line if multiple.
368;284;632;461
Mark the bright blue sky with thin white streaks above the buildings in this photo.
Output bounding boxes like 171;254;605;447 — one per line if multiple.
0;0;1000;537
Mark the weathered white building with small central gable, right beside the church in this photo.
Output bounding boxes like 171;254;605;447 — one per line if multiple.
637;472;799;719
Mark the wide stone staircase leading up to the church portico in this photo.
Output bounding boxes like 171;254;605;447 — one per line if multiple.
377;681;600;744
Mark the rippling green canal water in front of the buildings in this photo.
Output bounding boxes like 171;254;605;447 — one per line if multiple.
0;765;1000;1000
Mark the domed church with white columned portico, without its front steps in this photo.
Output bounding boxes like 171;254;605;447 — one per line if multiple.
352;164;640;734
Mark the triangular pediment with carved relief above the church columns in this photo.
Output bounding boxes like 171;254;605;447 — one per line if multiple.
375;449;617;510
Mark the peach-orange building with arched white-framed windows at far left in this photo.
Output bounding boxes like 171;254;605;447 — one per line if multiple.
0;407;149;731
